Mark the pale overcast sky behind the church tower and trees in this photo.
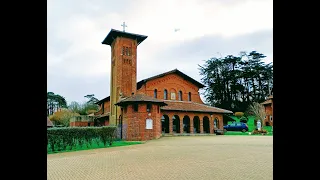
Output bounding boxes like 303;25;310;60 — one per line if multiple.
47;0;273;104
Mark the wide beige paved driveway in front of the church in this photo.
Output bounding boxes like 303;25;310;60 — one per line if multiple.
47;136;273;180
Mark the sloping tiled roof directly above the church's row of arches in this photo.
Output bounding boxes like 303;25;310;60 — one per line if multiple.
161;100;233;113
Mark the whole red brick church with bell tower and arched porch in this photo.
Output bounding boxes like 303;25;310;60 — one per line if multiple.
74;29;232;141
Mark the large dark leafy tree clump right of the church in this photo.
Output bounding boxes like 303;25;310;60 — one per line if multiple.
199;51;273;112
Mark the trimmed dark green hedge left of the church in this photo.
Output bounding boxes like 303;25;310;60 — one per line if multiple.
47;126;117;152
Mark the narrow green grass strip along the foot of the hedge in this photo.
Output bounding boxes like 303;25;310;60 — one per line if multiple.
47;141;142;154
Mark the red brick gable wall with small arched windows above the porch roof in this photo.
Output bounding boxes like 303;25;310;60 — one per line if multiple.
137;74;203;104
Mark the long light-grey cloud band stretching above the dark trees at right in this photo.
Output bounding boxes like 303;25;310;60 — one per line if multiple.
151;30;273;63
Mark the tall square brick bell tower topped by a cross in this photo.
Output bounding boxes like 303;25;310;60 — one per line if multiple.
102;27;148;125
